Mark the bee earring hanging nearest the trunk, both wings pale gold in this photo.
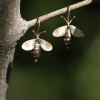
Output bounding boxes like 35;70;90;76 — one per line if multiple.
22;17;53;62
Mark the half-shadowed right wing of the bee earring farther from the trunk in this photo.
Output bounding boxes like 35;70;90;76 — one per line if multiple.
69;25;84;37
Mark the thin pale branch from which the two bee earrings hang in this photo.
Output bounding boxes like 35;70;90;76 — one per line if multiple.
27;0;100;27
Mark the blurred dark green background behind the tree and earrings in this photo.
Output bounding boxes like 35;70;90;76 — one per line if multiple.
7;0;100;100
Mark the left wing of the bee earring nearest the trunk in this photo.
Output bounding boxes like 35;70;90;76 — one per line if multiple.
22;39;36;51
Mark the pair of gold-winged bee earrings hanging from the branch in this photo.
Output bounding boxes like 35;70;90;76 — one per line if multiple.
22;7;84;62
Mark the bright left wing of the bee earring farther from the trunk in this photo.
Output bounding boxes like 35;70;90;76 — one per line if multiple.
53;25;67;37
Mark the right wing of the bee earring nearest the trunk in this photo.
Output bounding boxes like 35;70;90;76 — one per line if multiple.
39;39;53;51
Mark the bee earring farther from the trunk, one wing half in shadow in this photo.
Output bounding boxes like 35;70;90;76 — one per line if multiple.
53;6;84;49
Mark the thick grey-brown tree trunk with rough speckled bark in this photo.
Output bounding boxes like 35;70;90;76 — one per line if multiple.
0;0;27;100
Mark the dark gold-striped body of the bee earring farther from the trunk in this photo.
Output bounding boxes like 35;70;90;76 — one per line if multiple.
64;27;73;49
